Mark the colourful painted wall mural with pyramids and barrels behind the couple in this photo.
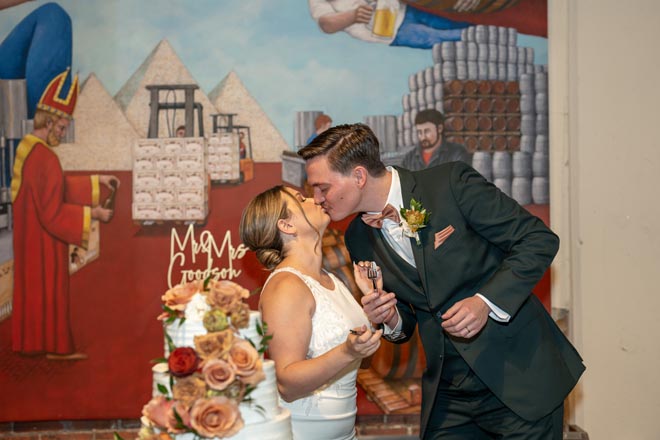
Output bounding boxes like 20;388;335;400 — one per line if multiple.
0;0;549;421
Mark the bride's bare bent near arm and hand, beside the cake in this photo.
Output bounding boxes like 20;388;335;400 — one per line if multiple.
260;272;381;402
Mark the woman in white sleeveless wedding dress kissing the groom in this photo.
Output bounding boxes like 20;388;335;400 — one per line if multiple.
240;186;382;440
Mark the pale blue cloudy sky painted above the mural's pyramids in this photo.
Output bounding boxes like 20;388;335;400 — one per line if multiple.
0;0;547;145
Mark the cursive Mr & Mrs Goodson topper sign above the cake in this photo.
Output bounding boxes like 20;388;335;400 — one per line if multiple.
167;225;248;288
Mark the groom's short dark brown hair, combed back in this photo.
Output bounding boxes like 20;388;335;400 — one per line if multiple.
298;124;386;177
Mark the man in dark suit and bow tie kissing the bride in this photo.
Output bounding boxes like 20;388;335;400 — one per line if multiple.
298;124;584;439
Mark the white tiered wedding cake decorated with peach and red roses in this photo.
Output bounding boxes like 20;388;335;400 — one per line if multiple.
140;281;292;440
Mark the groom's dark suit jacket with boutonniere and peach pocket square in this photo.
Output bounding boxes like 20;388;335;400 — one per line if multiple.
346;162;584;438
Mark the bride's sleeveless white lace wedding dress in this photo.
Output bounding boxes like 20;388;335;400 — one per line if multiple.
266;267;369;440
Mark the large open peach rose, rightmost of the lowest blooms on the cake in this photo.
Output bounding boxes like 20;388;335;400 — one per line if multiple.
190;396;244;438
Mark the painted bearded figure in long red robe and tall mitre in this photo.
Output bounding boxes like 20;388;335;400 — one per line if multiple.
11;69;119;360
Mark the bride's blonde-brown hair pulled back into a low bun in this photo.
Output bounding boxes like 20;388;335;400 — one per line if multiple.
239;185;321;270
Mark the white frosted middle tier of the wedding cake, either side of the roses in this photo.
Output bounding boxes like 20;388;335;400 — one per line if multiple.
152;359;282;425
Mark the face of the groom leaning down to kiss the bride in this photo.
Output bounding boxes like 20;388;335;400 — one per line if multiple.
306;156;360;221
